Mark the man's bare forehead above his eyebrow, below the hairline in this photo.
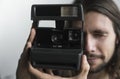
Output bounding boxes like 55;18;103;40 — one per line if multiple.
84;12;113;31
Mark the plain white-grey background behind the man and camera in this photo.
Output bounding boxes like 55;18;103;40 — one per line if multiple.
0;0;120;79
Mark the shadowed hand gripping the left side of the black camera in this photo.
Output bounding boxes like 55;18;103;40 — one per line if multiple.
16;28;36;79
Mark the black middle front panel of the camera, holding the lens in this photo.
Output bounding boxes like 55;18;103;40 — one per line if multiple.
33;27;81;49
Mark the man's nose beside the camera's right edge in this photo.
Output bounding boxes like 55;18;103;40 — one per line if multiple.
85;34;96;53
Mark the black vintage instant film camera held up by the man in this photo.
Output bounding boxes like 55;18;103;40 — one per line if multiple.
30;4;84;70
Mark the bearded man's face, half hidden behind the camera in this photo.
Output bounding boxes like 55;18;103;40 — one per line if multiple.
76;12;116;72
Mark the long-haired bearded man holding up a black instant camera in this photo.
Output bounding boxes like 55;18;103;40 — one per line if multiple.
17;0;120;79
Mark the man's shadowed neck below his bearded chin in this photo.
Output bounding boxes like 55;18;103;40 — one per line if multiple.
88;70;110;79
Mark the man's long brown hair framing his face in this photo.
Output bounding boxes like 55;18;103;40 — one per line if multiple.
74;0;120;79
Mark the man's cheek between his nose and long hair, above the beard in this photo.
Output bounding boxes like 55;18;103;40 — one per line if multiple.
98;38;115;62
